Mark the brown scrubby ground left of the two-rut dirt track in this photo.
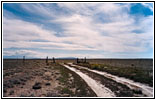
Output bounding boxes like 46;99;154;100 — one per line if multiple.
3;60;96;97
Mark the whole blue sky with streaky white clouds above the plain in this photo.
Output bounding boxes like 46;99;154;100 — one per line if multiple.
3;2;154;58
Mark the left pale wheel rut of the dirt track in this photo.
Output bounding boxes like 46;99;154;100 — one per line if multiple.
63;65;115;97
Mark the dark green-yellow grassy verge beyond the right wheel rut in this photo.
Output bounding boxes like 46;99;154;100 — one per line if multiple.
77;63;153;86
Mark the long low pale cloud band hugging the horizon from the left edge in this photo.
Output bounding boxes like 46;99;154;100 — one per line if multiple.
3;49;103;58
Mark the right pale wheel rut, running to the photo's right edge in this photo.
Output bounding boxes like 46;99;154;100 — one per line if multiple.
68;63;153;97
